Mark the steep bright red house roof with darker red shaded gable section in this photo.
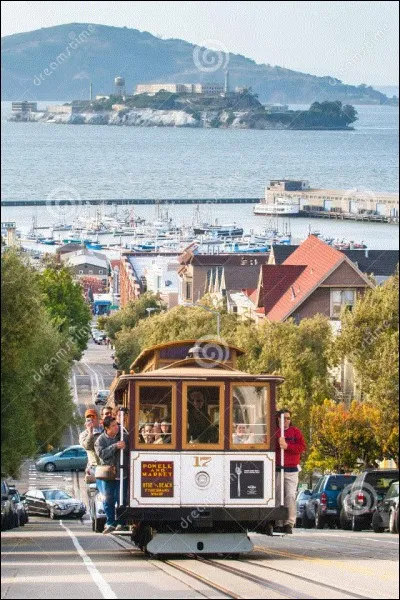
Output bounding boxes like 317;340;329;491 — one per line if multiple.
262;235;346;321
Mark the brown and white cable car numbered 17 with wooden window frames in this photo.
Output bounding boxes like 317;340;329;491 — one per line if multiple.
108;340;287;554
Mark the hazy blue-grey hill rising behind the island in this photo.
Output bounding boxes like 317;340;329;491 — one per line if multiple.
2;23;393;104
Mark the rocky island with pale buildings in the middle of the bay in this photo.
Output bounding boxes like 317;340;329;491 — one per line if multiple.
10;88;357;130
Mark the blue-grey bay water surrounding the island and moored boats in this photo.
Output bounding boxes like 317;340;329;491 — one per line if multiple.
2;103;398;248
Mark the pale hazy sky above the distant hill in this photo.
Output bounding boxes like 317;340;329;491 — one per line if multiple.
1;1;399;85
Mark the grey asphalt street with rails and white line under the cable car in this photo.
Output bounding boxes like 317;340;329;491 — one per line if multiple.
1;344;399;599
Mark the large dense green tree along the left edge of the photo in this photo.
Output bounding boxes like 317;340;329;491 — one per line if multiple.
1;250;76;475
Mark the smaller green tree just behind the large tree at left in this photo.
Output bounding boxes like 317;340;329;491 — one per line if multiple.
39;265;92;360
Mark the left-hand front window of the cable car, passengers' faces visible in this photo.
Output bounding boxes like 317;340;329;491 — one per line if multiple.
135;384;174;447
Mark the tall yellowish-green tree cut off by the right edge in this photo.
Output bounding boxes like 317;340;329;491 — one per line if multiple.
335;272;399;462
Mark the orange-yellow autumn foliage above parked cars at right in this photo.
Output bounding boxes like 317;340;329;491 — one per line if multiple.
305;400;382;472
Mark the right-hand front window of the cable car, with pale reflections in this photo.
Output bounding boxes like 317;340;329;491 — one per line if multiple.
231;385;269;446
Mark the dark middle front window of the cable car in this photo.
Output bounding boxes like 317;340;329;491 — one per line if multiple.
186;386;221;444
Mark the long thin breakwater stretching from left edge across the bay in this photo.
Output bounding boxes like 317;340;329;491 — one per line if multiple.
1;198;260;206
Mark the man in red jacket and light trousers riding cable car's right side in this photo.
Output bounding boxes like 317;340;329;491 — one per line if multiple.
274;408;306;533
